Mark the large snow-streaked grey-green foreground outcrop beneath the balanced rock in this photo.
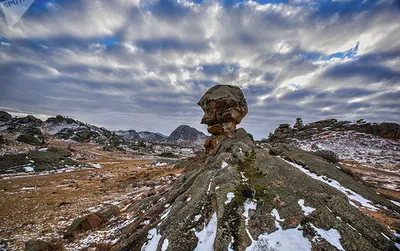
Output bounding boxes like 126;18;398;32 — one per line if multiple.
113;85;400;251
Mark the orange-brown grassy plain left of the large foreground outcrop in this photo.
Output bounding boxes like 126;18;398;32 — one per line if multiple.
0;156;183;250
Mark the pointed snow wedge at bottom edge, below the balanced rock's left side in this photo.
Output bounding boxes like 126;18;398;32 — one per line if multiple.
193;212;217;251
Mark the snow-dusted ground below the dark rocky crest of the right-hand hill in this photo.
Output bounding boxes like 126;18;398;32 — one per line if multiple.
294;131;400;191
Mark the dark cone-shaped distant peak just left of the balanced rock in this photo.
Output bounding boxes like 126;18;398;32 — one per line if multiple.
167;125;207;146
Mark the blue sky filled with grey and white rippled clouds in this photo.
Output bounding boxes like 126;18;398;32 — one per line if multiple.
0;0;400;139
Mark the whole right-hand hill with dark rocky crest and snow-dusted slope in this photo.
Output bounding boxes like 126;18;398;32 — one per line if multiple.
269;119;400;197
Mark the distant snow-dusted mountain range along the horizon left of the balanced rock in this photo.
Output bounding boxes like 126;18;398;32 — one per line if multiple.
0;111;207;147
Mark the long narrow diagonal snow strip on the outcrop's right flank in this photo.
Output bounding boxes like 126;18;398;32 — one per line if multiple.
282;158;379;211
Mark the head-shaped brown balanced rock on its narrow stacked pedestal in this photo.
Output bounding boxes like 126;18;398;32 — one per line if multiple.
198;85;248;153
